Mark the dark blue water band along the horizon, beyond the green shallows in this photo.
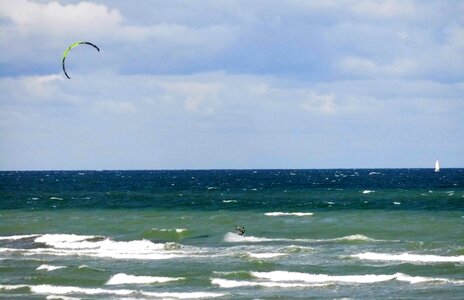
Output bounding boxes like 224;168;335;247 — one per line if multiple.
0;169;464;211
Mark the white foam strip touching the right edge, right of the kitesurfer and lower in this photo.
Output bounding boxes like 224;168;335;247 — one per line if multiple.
352;252;464;263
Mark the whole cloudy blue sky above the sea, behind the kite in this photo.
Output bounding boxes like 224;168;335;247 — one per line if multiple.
0;0;464;170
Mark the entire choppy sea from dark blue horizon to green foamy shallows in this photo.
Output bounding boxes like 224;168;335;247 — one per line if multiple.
0;169;464;300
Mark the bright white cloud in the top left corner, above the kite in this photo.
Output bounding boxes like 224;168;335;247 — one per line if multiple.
0;0;239;45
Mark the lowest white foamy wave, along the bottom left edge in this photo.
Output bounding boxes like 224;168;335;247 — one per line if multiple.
0;284;227;299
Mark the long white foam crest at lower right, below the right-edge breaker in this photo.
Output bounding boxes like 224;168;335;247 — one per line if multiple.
251;271;458;284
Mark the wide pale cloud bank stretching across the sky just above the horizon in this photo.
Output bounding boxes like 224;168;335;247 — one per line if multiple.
0;72;464;169
